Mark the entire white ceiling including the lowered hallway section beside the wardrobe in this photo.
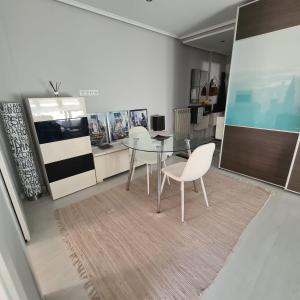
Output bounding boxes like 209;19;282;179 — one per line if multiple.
56;0;247;55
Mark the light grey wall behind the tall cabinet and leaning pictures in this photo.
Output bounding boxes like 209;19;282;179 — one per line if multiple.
0;0;225;189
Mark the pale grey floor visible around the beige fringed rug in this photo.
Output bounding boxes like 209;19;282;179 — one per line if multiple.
25;155;300;300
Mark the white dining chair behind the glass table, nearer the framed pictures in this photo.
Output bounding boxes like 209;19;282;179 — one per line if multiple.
129;126;170;195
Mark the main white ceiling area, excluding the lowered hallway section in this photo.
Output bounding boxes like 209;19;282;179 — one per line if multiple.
66;0;242;37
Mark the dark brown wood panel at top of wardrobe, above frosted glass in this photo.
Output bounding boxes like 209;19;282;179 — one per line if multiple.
236;0;300;40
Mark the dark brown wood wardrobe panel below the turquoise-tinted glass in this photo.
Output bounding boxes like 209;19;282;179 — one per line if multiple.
221;126;298;186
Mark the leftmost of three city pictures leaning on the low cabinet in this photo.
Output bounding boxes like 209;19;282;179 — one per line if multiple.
87;113;109;146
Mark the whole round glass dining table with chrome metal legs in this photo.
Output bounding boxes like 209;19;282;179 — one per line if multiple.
122;135;212;213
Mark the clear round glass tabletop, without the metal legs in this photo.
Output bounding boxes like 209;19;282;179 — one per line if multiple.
122;135;212;152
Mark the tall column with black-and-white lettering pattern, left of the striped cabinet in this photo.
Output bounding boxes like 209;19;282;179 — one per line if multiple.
0;102;42;198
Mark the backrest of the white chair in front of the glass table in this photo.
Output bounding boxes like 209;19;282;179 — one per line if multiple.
181;143;216;181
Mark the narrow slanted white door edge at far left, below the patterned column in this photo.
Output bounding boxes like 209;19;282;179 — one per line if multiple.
0;149;30;241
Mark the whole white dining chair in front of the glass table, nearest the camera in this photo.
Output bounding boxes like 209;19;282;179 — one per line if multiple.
161;143;215;223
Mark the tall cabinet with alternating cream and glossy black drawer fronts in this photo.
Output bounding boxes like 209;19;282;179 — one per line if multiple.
27;97;96;200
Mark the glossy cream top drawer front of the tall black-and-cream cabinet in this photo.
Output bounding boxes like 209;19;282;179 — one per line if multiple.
28;97;86;122
